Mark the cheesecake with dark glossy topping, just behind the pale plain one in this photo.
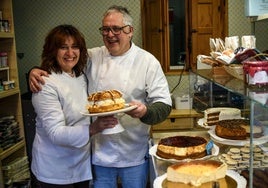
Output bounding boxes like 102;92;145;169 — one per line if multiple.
156;136;207;160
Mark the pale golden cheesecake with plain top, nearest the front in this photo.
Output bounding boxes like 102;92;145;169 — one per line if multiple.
167;160;227;186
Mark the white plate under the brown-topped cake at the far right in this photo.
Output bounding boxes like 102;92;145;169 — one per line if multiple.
208;128;268;146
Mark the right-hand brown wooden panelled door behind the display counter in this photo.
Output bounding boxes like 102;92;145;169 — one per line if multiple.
188;0;227;69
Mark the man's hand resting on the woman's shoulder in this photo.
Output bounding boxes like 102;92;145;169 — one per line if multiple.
29;68;48;93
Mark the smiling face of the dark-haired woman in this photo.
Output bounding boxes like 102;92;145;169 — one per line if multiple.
57;37;80;73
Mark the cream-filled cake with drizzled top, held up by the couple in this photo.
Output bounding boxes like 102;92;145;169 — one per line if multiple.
87;90;125;113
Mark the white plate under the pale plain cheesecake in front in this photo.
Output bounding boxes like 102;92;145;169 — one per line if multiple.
154;170;247;188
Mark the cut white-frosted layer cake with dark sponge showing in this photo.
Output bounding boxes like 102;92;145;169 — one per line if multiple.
204;107;241;126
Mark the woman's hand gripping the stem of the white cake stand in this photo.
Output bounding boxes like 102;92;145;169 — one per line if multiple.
90;116;118;136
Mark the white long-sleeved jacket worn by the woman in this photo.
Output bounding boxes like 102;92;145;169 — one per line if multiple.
31;72;92;184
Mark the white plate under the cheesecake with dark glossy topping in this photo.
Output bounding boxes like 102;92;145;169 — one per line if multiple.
149;144;219;163
